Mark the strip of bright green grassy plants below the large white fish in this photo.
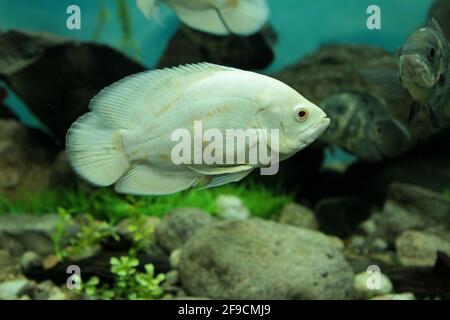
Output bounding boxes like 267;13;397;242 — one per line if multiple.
0;181;293;220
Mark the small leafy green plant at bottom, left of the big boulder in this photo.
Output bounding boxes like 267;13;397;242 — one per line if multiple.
81;256;165;300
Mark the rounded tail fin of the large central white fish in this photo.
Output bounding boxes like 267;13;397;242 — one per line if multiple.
66;112;130;187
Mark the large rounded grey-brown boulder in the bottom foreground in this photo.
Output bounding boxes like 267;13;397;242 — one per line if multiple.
179;219;353;300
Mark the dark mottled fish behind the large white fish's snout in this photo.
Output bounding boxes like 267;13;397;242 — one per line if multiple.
320;90;411;161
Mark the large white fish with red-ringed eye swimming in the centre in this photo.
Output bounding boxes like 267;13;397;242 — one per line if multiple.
66;63;329;195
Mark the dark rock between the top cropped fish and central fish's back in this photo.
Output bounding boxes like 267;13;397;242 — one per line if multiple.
159;25;274;70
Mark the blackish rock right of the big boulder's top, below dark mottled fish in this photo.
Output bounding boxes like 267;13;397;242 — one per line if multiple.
314;197;369;238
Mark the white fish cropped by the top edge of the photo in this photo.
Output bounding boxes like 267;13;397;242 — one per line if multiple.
136;0;270;36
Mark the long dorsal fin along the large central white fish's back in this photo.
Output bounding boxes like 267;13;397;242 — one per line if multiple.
89;63;235;129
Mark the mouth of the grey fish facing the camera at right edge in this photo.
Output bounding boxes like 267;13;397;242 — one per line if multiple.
400;54;437;88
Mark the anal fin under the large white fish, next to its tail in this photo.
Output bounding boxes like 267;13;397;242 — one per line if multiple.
115;164;197;195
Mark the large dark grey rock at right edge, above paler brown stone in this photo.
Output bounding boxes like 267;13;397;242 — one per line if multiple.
373;183;450;243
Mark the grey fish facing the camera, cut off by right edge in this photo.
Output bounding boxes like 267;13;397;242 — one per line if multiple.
399;18;450;127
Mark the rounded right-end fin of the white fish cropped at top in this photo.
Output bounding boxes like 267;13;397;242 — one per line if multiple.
220;0;270;35
